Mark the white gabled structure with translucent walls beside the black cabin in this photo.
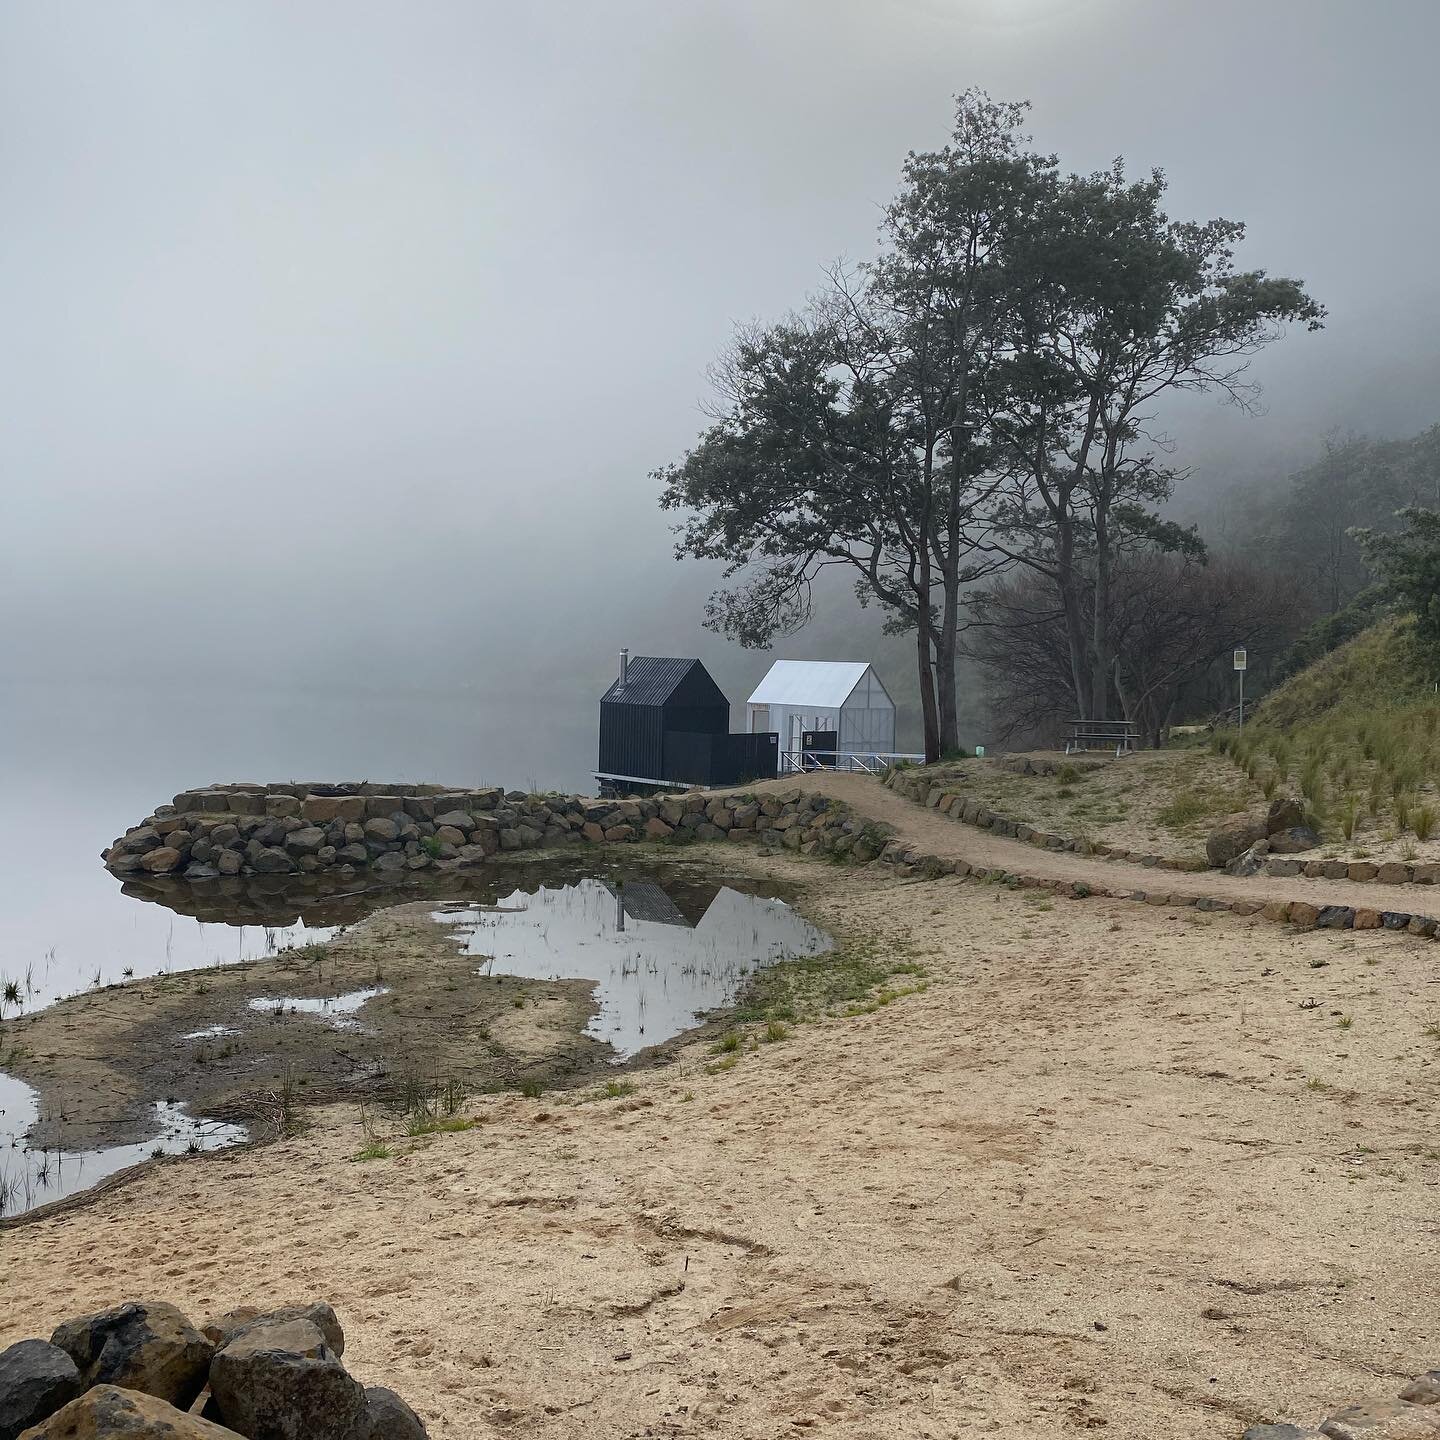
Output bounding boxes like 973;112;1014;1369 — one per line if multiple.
744;660;896;759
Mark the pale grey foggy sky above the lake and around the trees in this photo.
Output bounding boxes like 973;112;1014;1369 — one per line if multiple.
0;0;1440;704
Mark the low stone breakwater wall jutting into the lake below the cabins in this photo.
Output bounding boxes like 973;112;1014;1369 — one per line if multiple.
102;782;864;881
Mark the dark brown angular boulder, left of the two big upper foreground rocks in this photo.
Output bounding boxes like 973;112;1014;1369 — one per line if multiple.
50;1300;215;1410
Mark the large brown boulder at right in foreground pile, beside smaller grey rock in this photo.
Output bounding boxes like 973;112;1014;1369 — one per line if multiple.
210;1319;367;1440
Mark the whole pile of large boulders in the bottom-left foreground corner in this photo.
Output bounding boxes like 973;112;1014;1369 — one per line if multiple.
0;1302;426;1440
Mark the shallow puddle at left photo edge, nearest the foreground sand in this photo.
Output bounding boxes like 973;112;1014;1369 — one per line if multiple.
0;1076;245;1218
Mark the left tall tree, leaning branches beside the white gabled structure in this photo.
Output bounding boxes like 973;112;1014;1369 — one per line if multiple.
657;92;1056;759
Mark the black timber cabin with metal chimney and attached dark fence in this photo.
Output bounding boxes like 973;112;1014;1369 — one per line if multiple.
595;649;779;795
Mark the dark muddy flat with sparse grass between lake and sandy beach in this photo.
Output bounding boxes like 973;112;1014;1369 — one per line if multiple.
0;857;806;1149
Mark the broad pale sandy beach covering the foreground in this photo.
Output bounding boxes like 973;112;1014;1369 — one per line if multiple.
0;831;1440;1440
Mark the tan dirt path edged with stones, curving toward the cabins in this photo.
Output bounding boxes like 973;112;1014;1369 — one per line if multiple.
783;772;1440;914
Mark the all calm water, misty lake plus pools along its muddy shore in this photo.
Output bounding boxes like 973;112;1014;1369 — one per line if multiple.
0;685;829;1214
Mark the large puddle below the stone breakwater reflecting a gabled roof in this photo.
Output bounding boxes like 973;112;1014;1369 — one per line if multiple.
435;880;832;1060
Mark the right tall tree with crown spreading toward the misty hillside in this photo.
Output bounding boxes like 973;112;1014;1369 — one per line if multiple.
988;161;1323;719
